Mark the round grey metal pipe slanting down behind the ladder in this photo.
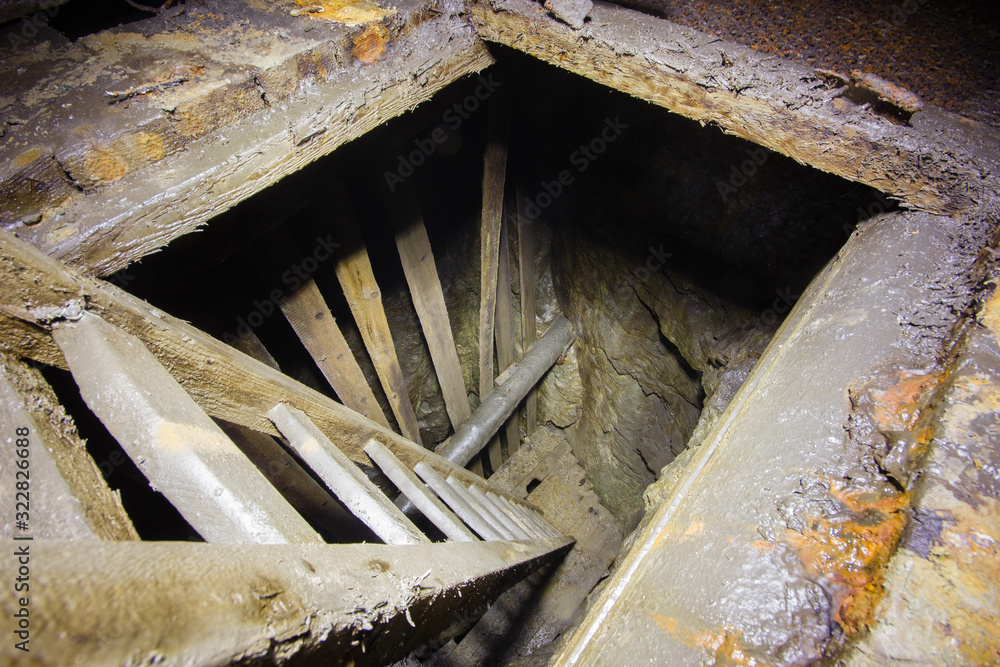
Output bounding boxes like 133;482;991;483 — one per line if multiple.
436;315;573;466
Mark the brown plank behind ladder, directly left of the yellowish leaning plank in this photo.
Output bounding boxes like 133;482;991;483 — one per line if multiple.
246;230;389;428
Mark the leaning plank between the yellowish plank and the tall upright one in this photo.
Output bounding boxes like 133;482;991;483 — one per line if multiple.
388;183;472;429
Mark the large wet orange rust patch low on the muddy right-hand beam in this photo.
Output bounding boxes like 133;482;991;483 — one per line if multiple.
785;485;910;635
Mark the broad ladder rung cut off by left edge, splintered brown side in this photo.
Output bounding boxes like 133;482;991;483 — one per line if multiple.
0;354;139;540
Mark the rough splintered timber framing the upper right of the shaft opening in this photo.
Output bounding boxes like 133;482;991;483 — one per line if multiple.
472;0;1000;213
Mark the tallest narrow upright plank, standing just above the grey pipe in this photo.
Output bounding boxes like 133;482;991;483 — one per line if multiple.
479;95;507;478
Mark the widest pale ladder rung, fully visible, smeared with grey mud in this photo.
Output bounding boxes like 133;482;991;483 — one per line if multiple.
53;313;322;544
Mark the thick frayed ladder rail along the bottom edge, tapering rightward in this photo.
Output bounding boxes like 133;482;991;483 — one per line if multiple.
0;538;569;665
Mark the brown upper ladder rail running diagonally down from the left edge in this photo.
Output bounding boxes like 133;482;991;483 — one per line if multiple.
0;230;500;498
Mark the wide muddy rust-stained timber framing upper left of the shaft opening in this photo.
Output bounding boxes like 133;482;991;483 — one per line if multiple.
0;0;493;275
